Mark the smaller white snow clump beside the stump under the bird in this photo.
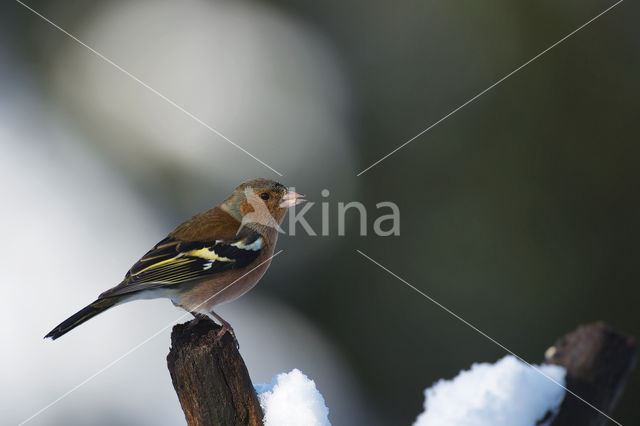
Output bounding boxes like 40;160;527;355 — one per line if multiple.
255;368;331;426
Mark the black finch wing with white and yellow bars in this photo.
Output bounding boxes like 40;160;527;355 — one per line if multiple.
100;232;264;297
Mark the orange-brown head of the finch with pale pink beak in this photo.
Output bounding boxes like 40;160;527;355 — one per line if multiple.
222;178;306;232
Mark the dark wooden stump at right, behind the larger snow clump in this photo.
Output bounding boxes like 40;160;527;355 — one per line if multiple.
545;322;638;426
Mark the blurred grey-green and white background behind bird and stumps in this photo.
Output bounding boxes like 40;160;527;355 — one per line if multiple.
0;0;640;425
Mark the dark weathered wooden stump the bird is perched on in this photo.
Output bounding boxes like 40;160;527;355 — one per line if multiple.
167;320;263;426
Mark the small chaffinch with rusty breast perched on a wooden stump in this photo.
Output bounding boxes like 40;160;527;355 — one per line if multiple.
45;178;306;340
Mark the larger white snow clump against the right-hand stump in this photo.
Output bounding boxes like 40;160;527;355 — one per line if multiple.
413;355;565;426
